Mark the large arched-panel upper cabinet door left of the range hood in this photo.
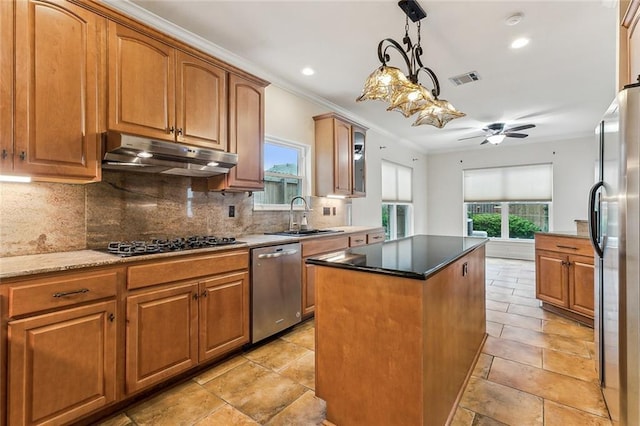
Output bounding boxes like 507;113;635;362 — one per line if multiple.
13;0;105;180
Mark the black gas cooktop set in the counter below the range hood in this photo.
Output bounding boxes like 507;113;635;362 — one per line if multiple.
107;235;237;257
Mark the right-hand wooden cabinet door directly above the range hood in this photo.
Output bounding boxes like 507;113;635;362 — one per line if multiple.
176;51;227;151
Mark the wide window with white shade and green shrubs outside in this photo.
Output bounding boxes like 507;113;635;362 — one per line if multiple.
464;164;553;240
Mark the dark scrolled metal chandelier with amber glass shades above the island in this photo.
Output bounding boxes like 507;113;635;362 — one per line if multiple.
356;0;465;128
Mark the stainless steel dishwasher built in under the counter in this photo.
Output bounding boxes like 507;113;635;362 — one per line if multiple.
251;243;302;343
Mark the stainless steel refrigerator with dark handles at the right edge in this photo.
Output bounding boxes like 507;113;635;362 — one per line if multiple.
589;83;640;426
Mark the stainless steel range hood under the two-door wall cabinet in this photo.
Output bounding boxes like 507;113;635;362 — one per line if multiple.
102;132;238;177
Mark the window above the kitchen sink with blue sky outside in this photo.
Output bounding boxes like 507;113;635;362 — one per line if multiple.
253;137;310;210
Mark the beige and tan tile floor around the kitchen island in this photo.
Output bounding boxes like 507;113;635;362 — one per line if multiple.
102;258;611;426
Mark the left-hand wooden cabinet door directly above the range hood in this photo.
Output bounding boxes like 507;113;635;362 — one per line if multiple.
108;22;177;141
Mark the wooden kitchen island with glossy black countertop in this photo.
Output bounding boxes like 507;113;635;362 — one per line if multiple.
307;235;487;426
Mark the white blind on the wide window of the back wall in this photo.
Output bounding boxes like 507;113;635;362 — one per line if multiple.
464;164;553;203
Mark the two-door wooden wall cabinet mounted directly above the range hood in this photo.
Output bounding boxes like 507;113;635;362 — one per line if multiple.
108;22;227;150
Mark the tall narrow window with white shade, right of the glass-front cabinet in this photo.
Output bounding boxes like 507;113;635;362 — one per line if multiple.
381;161;413;240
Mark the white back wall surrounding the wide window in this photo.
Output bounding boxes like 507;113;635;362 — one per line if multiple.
427;135;597;258
